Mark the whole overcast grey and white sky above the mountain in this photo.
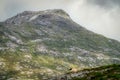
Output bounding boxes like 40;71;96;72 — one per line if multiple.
0;0;120;41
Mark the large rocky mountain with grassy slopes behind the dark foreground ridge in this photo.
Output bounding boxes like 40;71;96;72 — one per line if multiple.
0;9;120;80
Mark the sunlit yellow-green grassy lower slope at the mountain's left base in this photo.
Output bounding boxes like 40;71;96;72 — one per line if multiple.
0;51;77;80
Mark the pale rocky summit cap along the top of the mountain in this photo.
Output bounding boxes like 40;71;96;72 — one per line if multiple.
5;9;70;25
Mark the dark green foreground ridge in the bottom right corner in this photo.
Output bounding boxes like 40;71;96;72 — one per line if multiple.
62;65;120;80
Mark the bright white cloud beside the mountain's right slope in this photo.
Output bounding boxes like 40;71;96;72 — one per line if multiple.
66;0;120;40
